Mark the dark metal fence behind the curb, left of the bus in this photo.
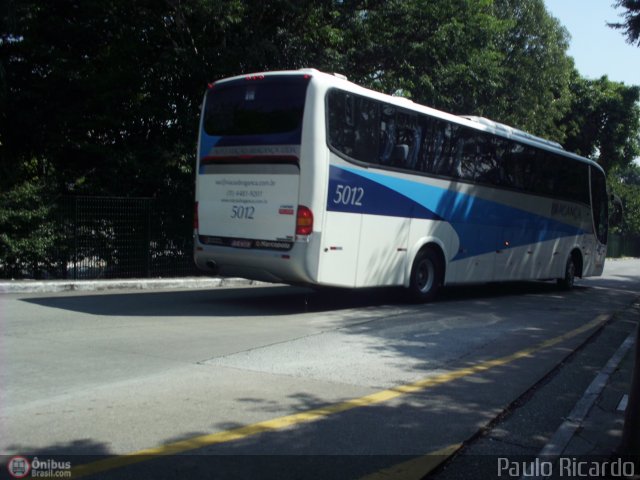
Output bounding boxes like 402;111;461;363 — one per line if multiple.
2;196;198;279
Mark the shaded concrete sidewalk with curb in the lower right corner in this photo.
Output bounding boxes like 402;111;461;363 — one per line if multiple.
425;298;640;480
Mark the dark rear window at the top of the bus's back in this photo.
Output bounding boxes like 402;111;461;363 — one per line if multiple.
203;75;309;136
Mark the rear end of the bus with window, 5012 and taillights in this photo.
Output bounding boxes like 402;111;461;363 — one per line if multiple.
194;72;313;283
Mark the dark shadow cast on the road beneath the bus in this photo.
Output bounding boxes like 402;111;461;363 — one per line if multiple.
23;282;589;317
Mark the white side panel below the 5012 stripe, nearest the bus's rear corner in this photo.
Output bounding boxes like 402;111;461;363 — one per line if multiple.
318;211;362;287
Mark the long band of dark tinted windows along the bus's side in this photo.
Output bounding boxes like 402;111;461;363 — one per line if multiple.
327;89;589;204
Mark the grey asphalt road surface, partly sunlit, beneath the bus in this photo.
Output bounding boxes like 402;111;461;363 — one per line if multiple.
0;260;640;478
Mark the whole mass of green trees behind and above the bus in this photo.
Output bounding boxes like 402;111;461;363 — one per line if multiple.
0;0;639;274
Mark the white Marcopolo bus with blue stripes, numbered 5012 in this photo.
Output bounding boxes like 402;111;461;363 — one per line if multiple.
194;69;608;301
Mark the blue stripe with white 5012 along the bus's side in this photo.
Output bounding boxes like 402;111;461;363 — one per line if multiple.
327;165;585;260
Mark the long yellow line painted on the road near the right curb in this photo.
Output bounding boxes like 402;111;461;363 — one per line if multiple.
72;314;610;478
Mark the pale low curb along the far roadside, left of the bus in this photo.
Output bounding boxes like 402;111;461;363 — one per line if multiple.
0;277;268;294
